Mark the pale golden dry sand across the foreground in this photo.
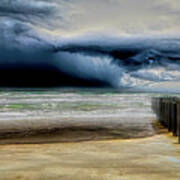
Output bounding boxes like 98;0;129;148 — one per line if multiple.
0;135;180;180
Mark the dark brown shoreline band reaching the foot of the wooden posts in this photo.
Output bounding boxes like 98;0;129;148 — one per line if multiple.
0;121;164;145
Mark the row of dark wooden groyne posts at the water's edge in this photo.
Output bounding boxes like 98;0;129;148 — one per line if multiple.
152;97;180;143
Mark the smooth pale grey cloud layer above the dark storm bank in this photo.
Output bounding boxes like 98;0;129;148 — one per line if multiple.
43;0;180;35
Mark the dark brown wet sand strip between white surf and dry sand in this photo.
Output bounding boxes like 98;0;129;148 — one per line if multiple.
0;118;158;145
